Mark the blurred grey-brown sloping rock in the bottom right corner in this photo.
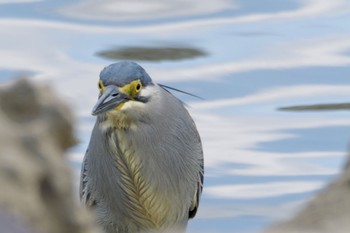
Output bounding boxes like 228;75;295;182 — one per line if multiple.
265;157;350;233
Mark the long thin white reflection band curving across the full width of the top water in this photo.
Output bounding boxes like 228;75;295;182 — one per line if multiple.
0;0;349;34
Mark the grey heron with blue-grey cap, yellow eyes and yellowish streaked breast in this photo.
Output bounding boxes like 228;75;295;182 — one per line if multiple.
80;62;203;233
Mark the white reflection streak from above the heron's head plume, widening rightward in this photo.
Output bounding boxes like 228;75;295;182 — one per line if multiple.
154;35;350;81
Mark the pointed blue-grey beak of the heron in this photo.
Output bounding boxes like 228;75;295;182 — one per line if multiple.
92;85;130;116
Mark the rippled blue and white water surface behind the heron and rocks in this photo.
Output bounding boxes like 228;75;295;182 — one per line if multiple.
0;0;350;233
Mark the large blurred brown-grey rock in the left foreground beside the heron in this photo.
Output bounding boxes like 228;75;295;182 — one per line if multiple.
0;80;98;233
